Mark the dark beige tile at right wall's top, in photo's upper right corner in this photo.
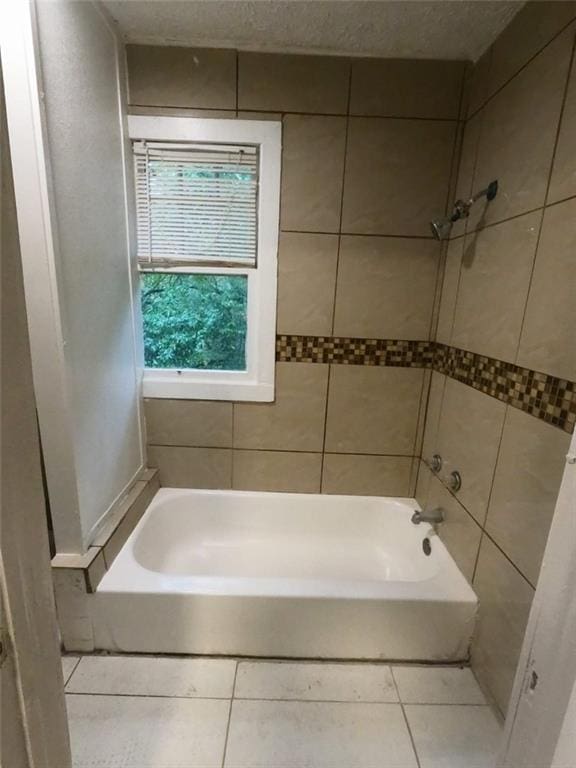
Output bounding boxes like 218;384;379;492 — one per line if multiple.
488;1;576;94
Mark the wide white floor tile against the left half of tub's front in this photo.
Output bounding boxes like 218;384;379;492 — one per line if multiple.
66;656;236;698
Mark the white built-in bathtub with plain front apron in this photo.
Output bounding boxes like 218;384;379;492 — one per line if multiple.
93;488;477;662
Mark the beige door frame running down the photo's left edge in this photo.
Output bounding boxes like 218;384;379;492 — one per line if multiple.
0;2;71;768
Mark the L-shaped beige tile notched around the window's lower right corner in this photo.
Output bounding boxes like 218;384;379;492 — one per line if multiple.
234;363;328;451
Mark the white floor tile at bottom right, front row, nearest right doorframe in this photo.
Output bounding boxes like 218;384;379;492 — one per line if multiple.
405;704;501;768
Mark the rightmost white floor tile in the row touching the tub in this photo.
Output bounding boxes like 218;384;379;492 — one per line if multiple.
392;667;486;704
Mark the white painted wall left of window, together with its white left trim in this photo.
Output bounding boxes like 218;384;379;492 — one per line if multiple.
2;0;144;553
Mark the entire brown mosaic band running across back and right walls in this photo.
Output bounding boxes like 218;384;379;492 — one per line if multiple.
276;335;576;434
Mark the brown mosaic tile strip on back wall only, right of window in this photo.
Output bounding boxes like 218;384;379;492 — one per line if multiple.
276;336;434;368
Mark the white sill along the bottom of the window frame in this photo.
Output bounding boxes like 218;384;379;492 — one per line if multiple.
142;370;274;403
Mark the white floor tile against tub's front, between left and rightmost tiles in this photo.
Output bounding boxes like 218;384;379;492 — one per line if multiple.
235;662;398;702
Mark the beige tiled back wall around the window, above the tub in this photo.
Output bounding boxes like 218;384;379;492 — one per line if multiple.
127;46;465;496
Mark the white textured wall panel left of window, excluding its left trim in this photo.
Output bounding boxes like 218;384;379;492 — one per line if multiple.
37;0;142;544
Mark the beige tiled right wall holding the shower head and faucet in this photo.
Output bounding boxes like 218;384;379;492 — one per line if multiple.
417;2;576;711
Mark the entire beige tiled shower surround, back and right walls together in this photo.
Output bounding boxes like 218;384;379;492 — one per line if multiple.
128;2;576;710
